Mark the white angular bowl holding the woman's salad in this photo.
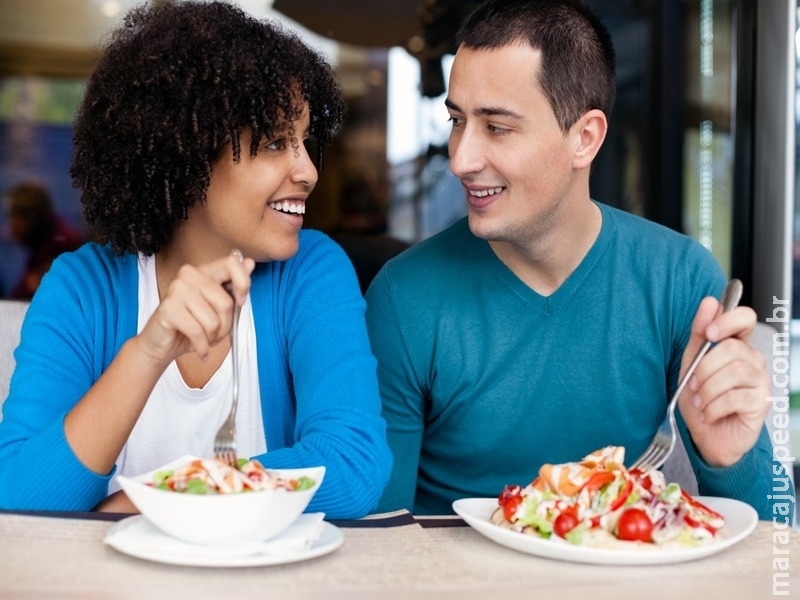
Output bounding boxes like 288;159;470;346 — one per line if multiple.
117;455;325;544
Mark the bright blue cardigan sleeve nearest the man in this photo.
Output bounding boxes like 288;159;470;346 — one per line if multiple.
252;231;392;518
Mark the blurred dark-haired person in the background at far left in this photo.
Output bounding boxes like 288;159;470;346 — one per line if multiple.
5;181;84;300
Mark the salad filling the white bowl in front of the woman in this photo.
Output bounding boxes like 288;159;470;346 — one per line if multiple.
149;458;314;494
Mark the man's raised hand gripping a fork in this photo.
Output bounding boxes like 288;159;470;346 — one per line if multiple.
678;298;769;467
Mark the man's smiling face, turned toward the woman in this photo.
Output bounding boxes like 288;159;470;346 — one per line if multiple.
446;44;580;245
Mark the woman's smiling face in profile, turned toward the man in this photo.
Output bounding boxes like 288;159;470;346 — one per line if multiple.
185;105;318;261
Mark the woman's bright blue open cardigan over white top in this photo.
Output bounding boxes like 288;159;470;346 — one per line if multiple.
0;230;392;518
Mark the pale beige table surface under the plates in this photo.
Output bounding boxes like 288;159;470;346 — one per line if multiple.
0;511;800;600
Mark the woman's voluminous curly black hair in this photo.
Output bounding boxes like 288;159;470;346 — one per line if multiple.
70;1;345;256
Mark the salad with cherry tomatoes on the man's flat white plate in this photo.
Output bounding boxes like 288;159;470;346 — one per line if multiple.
491;446;725;546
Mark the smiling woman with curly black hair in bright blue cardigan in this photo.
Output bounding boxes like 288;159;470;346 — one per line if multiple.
0;2;391;518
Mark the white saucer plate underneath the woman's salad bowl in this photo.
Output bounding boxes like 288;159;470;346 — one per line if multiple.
103;515;344;567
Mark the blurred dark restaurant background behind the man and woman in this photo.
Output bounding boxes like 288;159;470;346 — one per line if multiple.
0;0;800;454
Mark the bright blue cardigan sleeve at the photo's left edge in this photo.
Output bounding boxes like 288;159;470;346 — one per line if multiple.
0;247;124;510
